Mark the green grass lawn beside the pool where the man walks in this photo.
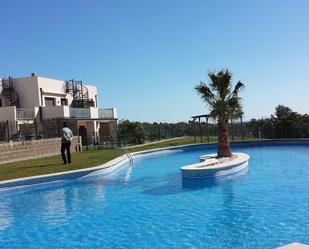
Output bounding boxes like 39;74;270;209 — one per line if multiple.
0;136;247;181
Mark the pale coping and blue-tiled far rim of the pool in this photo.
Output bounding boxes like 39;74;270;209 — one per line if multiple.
0;139;309;191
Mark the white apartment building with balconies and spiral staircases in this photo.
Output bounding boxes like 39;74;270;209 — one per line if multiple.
0;73;117;141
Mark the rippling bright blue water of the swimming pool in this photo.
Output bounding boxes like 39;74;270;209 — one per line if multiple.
0;145;309;249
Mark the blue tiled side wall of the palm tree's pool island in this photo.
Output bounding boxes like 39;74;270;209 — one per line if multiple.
182;167;249;190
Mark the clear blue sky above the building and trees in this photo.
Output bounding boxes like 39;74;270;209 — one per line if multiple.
0;0;309;122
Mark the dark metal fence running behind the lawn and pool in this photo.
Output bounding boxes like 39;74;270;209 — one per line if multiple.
0;120;309;148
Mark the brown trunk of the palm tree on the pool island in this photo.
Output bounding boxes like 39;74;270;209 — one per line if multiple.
218;120;232;158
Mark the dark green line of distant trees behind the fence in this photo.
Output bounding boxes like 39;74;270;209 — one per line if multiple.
118;105;309;144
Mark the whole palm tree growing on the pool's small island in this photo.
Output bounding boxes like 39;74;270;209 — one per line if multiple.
195;69;244;158
